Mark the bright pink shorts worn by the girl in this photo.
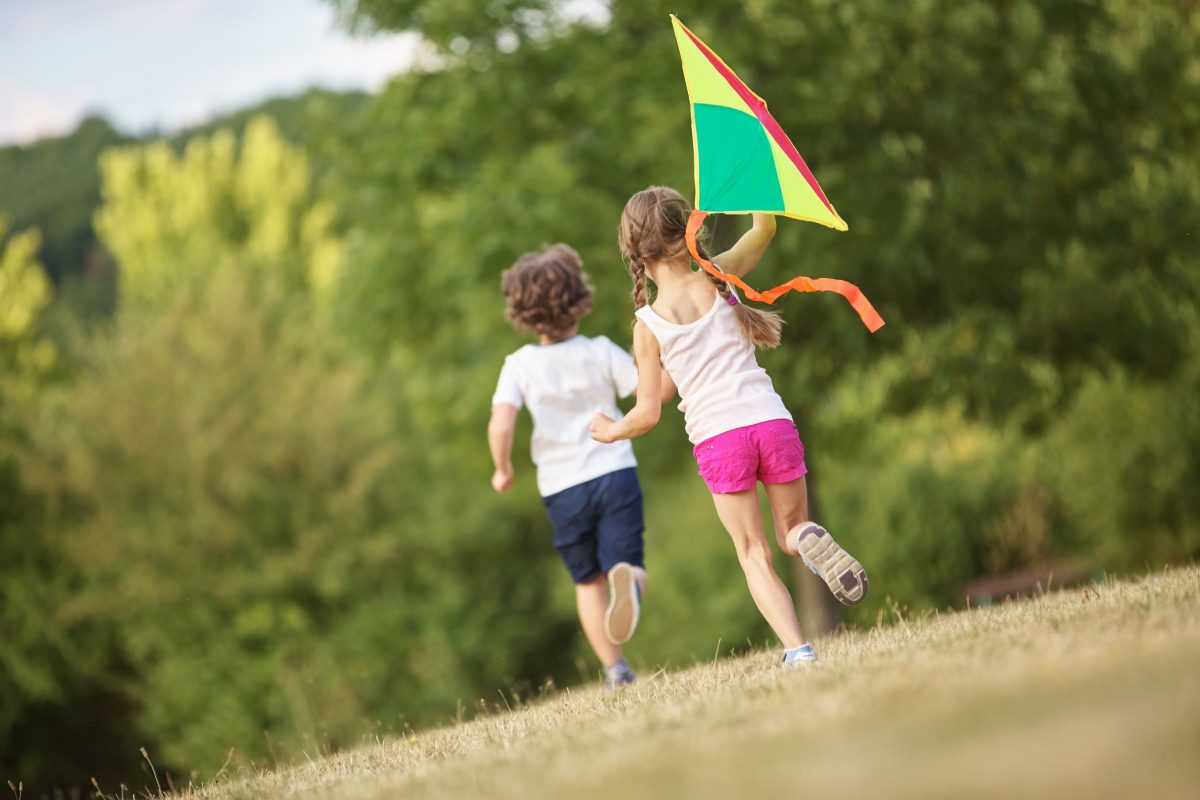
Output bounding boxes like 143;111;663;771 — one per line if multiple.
692;420;809;494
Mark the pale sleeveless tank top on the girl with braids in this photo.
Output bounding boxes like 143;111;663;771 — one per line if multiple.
635;295;792;445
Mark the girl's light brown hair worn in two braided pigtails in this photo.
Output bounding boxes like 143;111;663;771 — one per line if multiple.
617;186;784;348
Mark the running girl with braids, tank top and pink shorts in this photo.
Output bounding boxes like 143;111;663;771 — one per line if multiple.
592;186;868;668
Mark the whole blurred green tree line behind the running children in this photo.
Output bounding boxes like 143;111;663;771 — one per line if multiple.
0;0;1200;786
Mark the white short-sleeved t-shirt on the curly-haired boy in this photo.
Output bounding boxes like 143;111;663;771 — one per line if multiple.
492;336;637;497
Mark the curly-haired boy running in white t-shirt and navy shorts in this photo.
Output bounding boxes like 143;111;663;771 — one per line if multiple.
487;245;647;690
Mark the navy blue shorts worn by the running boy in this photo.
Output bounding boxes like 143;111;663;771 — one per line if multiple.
541;467;646;583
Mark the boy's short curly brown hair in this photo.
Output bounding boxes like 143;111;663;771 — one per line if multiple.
500;245;592;342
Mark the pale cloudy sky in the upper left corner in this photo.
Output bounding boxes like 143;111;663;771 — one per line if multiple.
0;0;419;145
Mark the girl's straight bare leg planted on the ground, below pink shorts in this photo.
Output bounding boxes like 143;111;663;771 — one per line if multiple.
713;487;804;649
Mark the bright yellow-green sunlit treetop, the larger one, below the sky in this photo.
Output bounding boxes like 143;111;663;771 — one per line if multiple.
96;116;342;307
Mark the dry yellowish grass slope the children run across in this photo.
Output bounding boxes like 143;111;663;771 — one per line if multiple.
171;567;1200;800
